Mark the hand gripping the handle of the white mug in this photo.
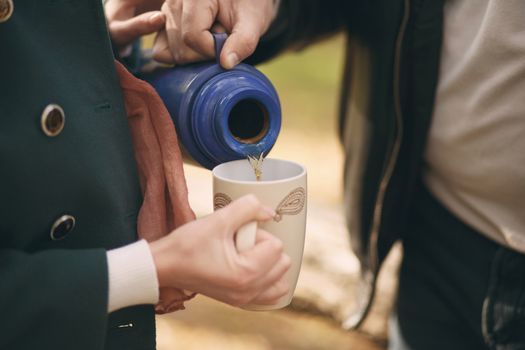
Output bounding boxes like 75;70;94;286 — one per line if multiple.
150;196;290;306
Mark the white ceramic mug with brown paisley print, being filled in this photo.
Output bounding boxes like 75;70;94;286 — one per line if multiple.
212;158;307;310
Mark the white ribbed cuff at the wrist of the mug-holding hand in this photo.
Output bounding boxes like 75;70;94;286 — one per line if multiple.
107;240;159;312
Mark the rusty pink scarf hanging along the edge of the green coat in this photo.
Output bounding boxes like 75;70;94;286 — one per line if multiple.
115;61;195;314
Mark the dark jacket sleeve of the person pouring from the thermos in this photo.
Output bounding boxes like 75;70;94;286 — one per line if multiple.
247;0;366;64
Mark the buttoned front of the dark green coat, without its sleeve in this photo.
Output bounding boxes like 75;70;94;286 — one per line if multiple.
0;0;154;349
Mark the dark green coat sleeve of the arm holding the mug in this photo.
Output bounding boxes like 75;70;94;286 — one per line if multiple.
0;249;108;350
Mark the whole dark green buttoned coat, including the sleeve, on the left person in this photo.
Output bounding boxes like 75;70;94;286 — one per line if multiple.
0;0;155;350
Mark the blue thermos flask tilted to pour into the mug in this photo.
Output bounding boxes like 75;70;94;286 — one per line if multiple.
143;34;281;169
